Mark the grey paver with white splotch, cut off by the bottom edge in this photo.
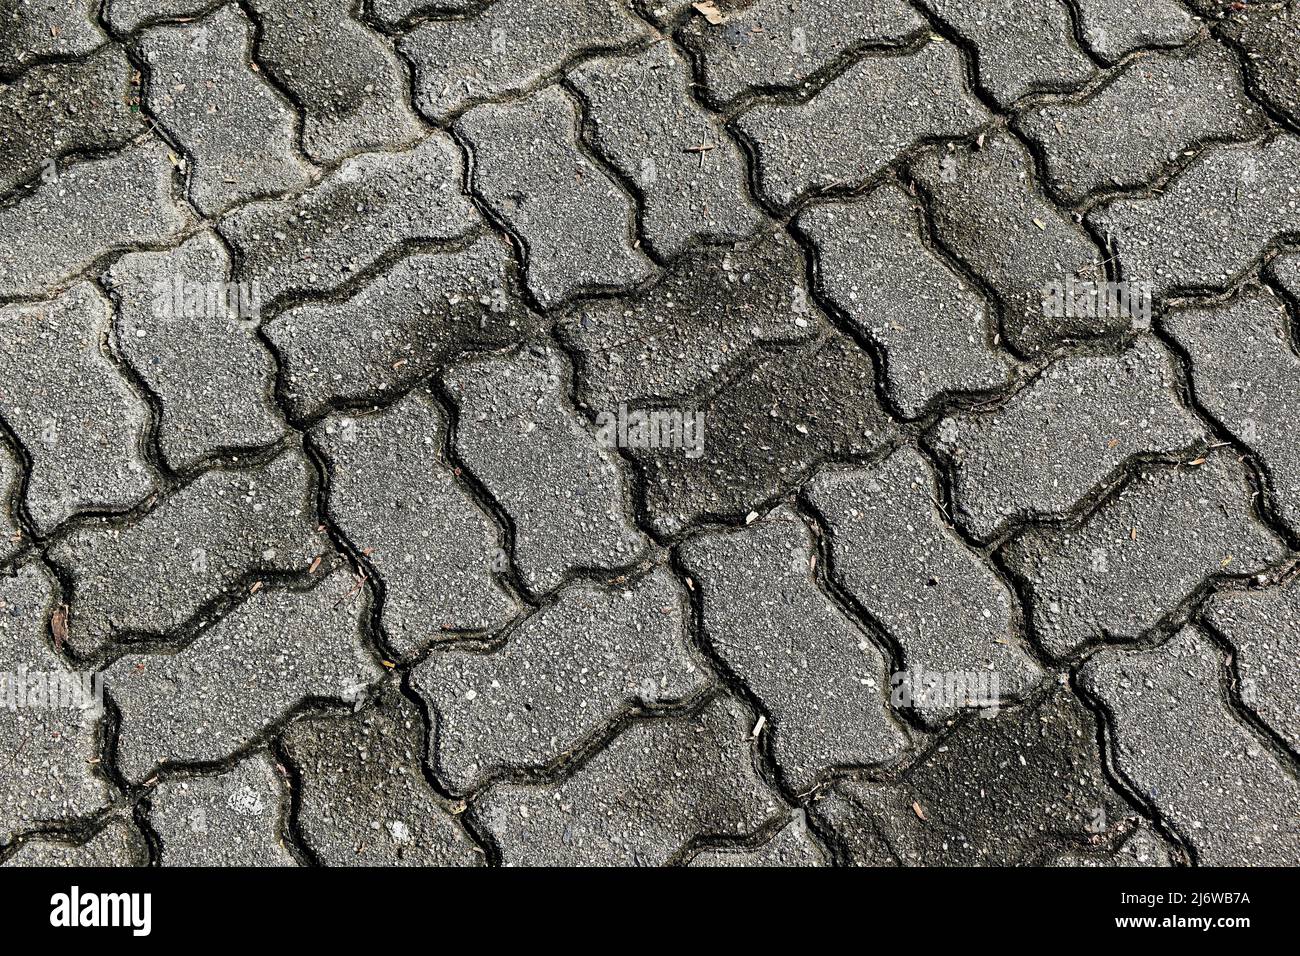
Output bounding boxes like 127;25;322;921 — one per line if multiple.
150;750;296;866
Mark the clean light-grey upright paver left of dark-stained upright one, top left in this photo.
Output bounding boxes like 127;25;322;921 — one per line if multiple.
139;5;311;216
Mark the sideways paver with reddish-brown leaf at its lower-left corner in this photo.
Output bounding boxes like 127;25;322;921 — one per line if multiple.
49;451;330;653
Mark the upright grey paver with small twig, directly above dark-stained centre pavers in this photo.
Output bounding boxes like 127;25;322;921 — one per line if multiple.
569;40;763;259
